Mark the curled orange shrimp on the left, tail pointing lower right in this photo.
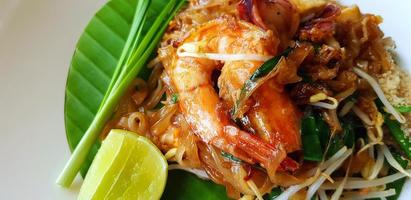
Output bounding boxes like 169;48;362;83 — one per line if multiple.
160;18;286;178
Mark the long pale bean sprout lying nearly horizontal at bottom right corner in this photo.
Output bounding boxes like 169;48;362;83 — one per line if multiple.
320;170;411;190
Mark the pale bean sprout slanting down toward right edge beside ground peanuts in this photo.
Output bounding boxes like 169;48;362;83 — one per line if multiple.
353;67;406;124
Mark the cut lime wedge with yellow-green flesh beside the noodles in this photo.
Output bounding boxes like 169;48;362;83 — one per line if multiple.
78;130;167;200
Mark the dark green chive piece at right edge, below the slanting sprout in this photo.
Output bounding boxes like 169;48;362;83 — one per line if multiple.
384;114;411;159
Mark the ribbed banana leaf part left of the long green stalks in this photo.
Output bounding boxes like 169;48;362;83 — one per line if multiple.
64;0;142;180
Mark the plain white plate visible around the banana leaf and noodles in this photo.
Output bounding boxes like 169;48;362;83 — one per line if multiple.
0;0;411;199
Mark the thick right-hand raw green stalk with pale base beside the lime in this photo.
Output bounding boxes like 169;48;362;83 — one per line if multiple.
57;0;186;187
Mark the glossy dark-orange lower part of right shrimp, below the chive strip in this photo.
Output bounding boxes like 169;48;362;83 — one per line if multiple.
247;81;301;152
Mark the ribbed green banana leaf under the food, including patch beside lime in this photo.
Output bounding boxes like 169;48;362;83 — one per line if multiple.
64;0;227;200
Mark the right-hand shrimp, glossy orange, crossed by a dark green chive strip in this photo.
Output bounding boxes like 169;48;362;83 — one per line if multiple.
218;44;301;152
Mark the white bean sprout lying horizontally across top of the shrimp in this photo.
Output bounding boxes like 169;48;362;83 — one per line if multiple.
177;42;272;62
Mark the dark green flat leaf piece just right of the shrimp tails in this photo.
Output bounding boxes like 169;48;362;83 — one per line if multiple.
301;113;323;161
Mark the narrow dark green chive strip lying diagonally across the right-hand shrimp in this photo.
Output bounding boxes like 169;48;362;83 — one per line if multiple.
231;47;293;120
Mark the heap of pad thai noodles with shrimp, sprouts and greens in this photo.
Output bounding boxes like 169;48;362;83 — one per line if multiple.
72;0;411;199
